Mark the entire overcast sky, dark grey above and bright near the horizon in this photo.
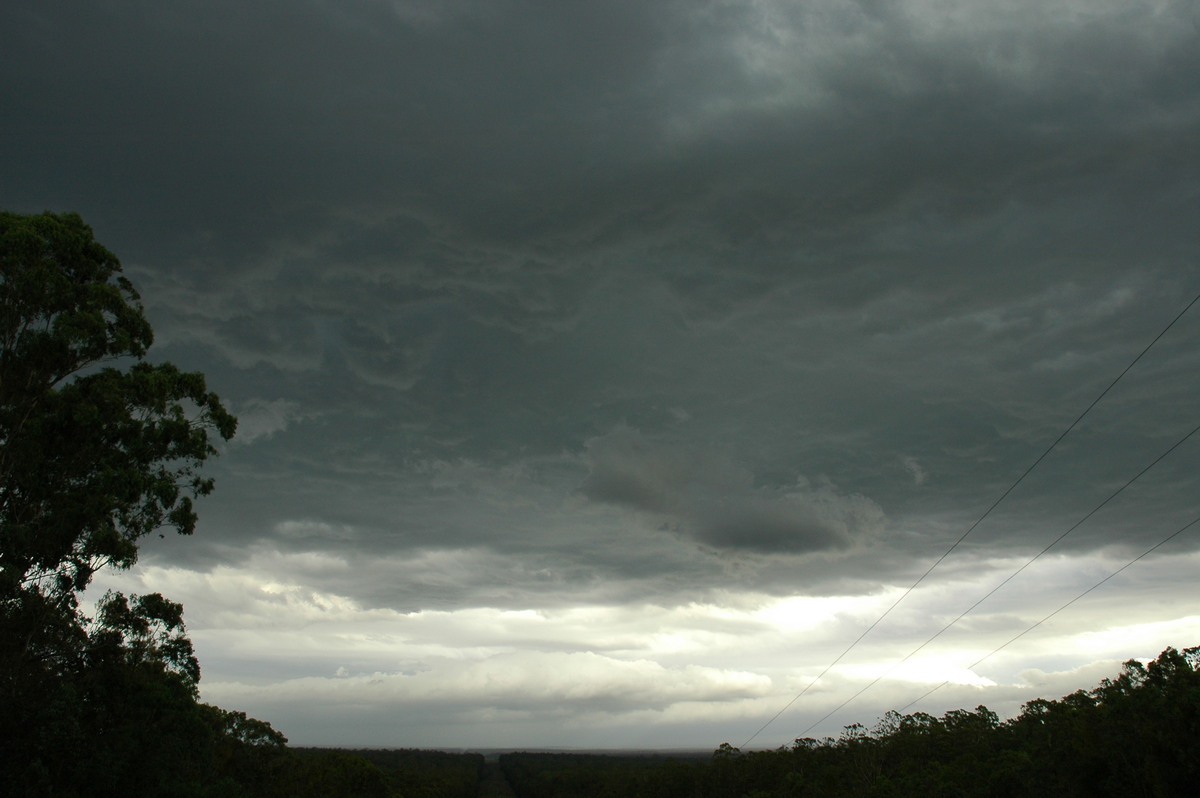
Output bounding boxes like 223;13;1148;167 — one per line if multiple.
0;0;1200;748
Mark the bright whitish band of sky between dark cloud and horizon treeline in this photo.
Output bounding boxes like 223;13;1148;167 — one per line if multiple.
88;542;1200;748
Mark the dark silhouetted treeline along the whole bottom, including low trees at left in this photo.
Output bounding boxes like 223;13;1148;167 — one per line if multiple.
5;647;1200;798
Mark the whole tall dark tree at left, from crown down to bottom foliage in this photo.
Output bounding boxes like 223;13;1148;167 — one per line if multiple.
0;212;265;796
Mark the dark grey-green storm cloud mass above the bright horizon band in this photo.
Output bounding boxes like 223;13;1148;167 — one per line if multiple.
0;1;1200;604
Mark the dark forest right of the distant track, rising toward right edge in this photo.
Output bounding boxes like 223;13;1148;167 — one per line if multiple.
500;647;1200;798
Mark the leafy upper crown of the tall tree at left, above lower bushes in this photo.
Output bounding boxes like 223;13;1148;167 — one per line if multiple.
0;214;236;602
